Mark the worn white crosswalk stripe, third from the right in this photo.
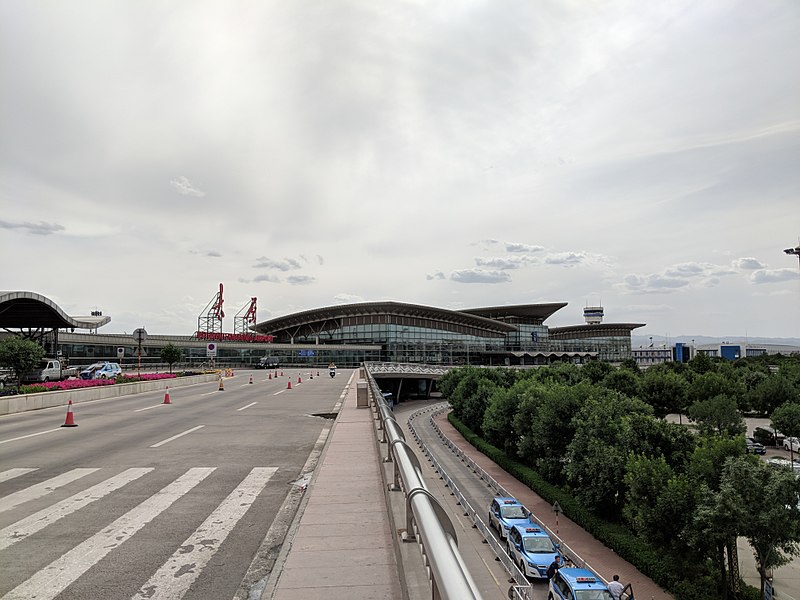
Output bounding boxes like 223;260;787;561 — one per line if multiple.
0;467;153;550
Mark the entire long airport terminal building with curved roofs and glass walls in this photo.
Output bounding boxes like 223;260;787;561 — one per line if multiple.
0;292;644;367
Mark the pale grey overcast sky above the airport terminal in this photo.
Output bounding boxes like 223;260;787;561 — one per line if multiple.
0;0;800;337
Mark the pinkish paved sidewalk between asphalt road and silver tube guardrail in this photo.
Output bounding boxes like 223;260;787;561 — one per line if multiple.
262;371;404;600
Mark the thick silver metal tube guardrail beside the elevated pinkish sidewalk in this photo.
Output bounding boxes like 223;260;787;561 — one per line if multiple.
364;368;483;600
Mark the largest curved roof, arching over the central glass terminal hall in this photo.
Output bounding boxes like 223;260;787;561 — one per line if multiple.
253;302;516;335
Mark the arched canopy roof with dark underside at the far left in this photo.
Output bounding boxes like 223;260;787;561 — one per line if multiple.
0;292;111;329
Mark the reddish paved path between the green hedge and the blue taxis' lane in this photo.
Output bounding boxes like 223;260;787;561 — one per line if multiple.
436;412;673;600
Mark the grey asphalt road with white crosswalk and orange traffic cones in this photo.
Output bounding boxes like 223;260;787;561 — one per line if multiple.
0;370;350;600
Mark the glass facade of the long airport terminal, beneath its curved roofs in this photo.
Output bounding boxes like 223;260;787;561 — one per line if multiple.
29;310;631;368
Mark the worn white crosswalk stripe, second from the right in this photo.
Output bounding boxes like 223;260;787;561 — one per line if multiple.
2;467;214;600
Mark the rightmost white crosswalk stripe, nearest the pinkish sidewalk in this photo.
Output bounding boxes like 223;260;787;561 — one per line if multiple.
132;467;278;600
